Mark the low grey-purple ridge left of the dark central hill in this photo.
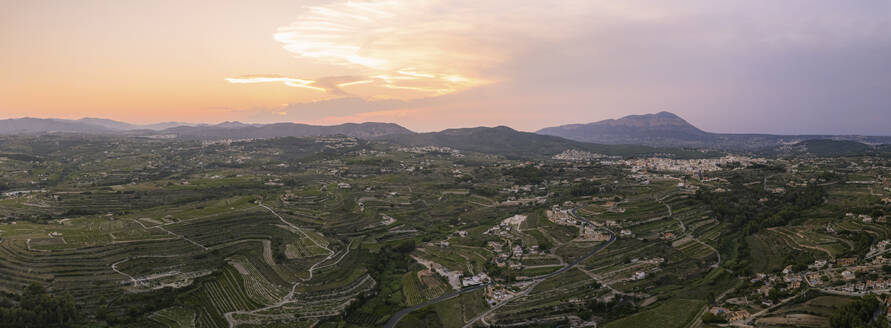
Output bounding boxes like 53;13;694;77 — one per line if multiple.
156;122;414;139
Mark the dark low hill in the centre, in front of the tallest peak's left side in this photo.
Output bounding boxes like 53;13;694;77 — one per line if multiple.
375;126;702;158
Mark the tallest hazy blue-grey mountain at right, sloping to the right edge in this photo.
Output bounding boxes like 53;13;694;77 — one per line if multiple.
536;112;891;150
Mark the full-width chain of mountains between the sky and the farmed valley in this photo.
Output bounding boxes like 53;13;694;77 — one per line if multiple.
0;111;891;153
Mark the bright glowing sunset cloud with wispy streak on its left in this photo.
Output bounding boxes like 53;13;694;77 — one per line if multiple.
226;0;504;99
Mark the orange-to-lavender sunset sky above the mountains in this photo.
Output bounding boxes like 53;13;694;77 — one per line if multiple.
0;0;891;135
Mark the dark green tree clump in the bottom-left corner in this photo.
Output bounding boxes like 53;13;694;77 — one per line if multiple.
0;284;78;328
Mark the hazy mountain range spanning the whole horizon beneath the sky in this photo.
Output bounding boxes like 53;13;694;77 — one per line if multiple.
0;112;891;156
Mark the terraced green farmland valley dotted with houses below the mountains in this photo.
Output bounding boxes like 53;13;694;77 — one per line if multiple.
0;135;891;328
